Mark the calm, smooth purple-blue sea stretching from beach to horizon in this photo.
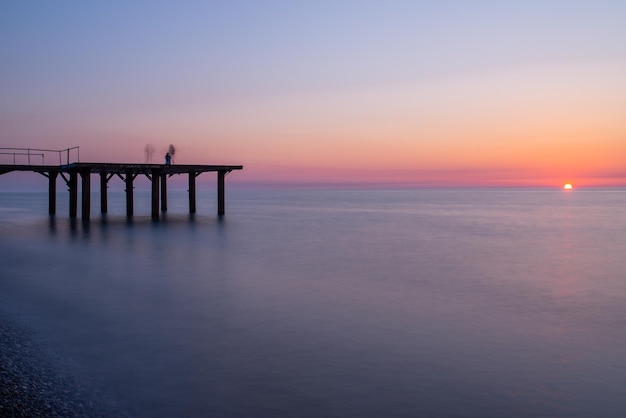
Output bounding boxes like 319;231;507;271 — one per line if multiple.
0;190;626;417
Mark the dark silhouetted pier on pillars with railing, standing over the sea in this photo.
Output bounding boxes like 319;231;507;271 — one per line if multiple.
0;147;243;220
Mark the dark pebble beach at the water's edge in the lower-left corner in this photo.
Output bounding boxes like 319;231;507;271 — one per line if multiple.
0;313;129;417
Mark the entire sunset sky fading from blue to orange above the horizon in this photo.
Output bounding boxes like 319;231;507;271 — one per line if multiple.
0;0;626;187
